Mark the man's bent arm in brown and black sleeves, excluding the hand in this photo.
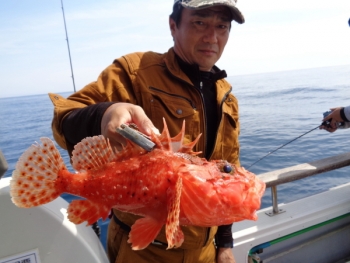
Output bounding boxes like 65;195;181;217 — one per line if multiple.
49;60;136;152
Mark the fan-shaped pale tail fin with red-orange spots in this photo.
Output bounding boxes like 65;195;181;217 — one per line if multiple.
10;138;67;208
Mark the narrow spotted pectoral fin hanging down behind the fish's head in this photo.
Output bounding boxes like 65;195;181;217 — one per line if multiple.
165;177;184;249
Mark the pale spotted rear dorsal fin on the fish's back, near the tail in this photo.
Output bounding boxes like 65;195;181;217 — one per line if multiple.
72;135;115;172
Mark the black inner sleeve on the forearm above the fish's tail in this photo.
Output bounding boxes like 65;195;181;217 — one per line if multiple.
62;102;115;145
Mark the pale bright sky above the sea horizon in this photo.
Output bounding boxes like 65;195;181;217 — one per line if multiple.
0;0;350;98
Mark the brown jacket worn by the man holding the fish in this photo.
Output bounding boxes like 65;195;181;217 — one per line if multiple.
50;49;239;262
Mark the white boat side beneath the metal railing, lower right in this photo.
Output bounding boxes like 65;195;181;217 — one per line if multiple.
233;183;350;263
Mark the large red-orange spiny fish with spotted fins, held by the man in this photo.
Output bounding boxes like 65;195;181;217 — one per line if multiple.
11;121;265;250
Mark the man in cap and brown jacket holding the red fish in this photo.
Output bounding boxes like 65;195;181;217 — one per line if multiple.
50;0;244;263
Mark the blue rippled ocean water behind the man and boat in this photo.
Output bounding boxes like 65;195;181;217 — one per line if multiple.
0;65;350;250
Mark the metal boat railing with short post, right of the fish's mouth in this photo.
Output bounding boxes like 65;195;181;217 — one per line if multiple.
258;152;350;216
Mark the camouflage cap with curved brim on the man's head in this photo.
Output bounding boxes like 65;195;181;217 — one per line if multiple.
174;0;244;24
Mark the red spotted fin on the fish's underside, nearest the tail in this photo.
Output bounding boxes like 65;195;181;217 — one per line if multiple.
67;200;110;225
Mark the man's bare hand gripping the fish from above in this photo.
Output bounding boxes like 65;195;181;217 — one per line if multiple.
101;102;159;150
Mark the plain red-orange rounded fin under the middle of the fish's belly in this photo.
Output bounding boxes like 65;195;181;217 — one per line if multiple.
128;217;164;250
